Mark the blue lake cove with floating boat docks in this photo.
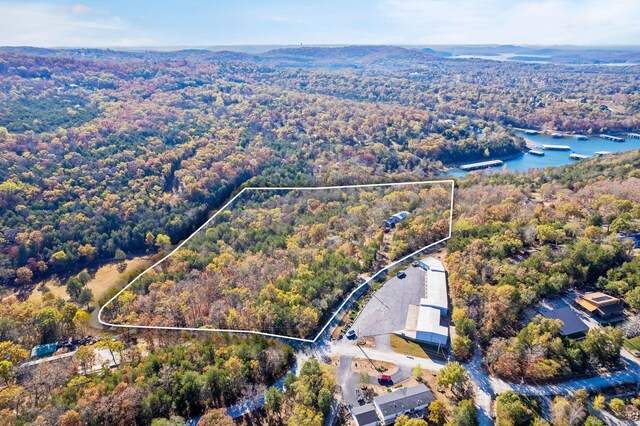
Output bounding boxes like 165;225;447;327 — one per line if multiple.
446;131;640;177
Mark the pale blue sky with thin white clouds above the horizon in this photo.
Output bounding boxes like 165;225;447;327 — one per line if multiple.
0;0;640;48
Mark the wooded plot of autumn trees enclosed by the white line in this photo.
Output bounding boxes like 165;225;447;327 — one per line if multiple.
100;180;453;341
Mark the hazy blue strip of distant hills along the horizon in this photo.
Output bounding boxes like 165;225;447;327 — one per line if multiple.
5;45;640;68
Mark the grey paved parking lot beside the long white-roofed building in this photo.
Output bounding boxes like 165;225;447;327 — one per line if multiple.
351;266;425;337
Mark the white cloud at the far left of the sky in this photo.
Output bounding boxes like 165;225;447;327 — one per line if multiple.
0;3;151;47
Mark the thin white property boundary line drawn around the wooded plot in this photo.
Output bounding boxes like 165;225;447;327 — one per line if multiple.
98;179;455;343
